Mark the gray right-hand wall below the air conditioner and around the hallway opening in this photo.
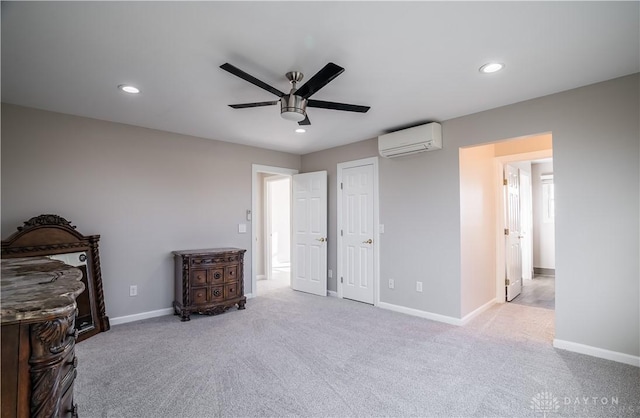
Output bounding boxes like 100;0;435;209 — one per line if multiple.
302;74;640;356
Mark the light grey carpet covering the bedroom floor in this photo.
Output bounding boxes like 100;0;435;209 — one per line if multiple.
75;288;640;418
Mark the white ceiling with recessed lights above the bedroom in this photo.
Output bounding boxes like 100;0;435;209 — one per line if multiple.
1;1;640;154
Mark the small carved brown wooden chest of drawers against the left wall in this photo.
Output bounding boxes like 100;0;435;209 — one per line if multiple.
173;248;247;321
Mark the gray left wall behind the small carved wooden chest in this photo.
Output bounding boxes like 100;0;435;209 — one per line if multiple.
2;104;300;318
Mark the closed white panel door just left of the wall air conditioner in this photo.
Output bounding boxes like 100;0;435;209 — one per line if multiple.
338;164;378;304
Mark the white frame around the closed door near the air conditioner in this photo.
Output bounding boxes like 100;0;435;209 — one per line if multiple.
336;157;380;306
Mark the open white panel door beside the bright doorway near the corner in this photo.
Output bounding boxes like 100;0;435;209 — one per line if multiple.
291;171;327;296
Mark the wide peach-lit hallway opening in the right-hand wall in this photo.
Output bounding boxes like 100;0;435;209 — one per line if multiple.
460;133;555;317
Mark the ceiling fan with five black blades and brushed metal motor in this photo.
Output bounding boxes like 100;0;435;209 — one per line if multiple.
220;62;369;125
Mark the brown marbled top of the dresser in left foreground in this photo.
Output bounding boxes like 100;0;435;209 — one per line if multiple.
0;257;84;324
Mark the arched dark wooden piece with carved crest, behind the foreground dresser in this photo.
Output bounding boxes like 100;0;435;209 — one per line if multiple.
2;215;110;341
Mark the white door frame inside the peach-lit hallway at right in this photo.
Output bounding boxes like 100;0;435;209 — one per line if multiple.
494;149;553;303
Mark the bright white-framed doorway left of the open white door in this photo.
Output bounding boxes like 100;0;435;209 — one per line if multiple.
251;164;298;297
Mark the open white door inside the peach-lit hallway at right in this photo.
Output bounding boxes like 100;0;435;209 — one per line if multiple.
504;165;522;301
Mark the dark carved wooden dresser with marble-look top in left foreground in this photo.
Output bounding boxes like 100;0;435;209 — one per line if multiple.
0;257;84;418
